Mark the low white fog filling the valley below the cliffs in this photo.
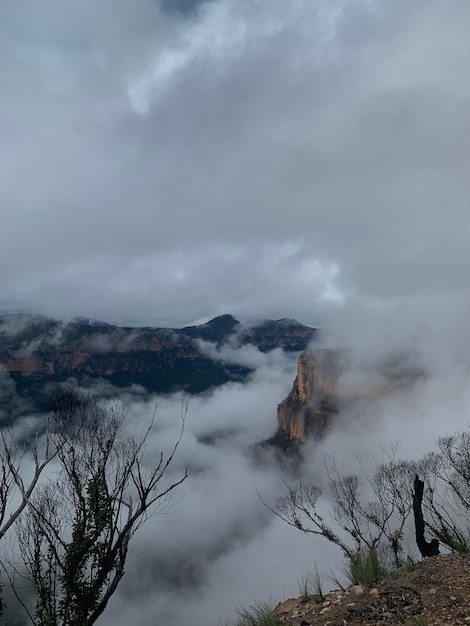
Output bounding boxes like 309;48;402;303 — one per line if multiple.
5;324;470;626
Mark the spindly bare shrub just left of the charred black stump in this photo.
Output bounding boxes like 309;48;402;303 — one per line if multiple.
268;448;413;565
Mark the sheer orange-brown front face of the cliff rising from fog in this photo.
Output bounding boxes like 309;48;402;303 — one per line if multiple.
275;349;342;442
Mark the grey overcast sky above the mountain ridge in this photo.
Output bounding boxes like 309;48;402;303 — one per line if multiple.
0;0;470;326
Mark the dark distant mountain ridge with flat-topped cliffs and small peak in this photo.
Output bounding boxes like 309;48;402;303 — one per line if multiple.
0;314;316;410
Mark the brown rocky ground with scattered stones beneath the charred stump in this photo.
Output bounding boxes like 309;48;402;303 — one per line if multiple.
275;554;470;626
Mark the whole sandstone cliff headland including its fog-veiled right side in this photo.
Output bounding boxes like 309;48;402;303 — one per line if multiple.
272;347;428;448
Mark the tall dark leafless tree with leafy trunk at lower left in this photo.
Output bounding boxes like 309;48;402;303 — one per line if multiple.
14;389;188;626
